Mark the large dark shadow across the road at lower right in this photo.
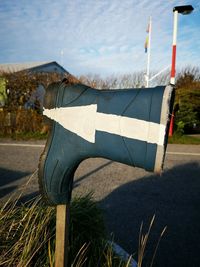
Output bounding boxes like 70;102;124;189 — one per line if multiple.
100;162;200;267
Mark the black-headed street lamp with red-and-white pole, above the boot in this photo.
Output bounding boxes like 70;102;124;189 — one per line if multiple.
170;5;194;85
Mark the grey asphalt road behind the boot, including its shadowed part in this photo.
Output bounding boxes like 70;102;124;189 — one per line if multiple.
0;139;200;267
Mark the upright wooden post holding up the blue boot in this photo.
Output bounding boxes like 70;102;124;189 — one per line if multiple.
55;205;69;267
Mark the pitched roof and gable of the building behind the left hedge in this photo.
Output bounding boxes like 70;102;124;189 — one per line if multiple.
0;61;69;74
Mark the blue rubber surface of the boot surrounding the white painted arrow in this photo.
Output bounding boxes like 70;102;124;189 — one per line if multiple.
38;83;173;205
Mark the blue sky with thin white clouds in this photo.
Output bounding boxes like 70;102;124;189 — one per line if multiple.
0;0;200;75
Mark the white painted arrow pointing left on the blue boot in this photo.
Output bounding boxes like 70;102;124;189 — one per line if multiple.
43;104;166;146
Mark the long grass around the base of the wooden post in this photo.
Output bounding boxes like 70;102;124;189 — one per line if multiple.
0;195;136;267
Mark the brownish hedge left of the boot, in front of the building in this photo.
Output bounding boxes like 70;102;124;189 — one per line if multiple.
0;71;81;137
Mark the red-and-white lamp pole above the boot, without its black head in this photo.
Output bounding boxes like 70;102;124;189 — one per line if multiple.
170;10;178;85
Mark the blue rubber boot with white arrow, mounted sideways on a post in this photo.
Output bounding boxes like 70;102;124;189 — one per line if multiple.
39;83;174;205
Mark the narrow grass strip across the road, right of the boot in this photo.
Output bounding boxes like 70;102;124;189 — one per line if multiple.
168;134;200;145
